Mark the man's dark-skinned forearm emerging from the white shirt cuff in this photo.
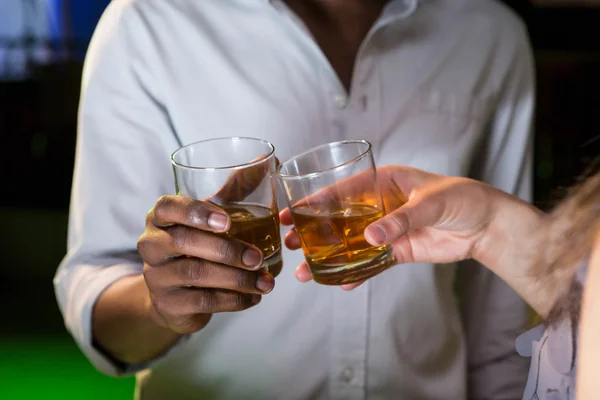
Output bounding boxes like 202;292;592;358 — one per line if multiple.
92;275;181;364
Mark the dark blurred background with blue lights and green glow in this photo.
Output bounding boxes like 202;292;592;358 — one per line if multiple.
0;0;600;400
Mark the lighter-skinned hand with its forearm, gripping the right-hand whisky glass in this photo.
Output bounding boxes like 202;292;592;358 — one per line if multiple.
281;166;549;315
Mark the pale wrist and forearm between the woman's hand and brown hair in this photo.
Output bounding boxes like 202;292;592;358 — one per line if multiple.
473;188;560;317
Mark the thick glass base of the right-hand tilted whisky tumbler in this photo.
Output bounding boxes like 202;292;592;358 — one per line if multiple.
308;248;394;286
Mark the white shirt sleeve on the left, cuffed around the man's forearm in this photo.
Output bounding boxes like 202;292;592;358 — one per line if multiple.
54;1;177;375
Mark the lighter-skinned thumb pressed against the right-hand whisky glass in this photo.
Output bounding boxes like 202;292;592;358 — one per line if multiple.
365;196;444;246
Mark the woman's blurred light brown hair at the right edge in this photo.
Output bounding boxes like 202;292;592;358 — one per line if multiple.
537;164;600;326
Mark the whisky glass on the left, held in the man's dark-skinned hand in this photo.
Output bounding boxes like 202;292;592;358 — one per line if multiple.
171;137;282;276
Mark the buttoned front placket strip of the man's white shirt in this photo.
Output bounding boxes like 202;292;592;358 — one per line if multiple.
273;0;416;400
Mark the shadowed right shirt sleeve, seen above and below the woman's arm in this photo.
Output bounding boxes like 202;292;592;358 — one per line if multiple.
457;14;535;400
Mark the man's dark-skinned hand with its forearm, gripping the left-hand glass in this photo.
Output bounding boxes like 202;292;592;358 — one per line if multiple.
92;158;275;364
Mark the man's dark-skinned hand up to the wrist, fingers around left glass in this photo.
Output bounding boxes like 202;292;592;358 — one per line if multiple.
138;196;275;334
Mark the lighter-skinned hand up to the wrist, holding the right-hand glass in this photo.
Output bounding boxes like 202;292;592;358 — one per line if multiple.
281;166;494;289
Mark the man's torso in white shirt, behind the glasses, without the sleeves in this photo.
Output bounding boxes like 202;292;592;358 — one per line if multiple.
91;0;528;400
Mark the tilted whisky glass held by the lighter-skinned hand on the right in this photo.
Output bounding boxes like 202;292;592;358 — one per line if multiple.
277;140;393;285
